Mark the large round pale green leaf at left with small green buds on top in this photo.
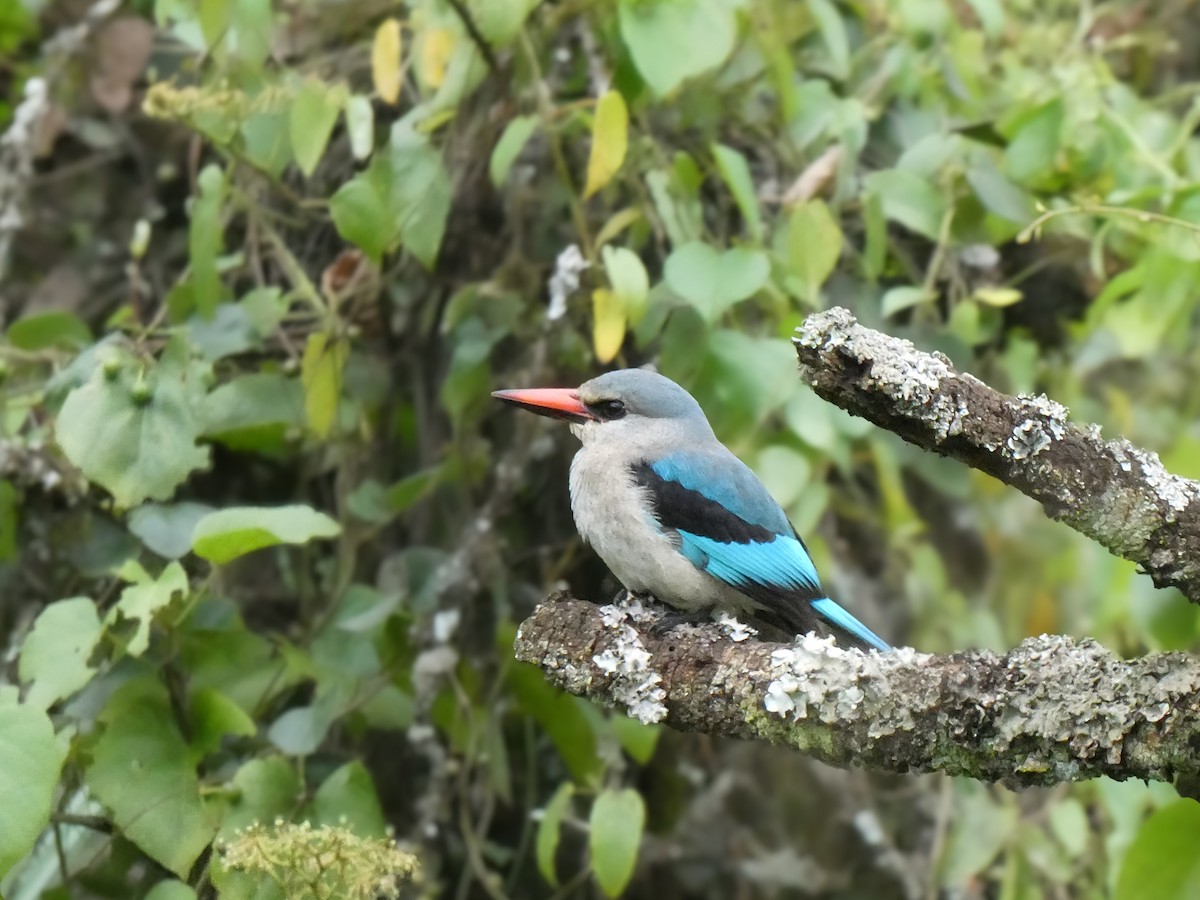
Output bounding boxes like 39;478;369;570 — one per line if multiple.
55;360;209;508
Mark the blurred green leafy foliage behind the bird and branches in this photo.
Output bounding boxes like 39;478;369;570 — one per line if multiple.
0;0;1200;900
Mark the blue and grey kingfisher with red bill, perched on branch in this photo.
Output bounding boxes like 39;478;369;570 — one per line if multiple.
492;368;892;650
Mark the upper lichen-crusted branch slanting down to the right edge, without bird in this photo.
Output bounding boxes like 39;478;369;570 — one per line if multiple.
794;308;1200;602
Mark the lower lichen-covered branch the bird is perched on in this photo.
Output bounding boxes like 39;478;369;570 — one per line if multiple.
516;595;1200;787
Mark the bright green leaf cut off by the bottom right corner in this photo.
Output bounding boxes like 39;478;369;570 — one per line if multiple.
1116;799;1200;900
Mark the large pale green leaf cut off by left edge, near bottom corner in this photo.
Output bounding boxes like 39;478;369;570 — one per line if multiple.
0;700;66;878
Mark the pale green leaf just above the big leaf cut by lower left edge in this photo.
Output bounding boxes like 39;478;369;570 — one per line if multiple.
18;596;100;709
